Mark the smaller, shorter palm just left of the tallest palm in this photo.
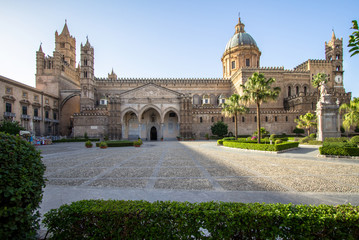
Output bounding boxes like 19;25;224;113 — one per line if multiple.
222;94;248;139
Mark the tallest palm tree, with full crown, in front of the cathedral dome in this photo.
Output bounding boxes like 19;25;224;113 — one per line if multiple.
241;72;280;143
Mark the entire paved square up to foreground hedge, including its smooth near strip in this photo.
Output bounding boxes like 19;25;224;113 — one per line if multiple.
38;141;359;213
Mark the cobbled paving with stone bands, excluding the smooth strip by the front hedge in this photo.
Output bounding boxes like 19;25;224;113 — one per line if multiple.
39;141;359;193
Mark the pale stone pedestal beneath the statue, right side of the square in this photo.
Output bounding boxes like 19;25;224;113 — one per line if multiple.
316;94;340;141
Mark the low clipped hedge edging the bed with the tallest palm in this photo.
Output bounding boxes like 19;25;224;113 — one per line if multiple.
223;141;299;151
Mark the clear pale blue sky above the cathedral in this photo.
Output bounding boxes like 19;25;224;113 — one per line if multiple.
0;0;359;97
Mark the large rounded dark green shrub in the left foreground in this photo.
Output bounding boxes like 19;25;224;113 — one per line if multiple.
0;132;45;239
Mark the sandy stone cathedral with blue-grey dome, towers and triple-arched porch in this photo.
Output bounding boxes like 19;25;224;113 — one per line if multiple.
31;19;351;140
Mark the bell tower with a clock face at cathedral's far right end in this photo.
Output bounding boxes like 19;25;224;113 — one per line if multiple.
325;30;344;91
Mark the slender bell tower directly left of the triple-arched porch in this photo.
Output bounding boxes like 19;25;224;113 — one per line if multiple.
80;38;95;109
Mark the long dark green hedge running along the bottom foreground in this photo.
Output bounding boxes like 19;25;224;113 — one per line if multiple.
44;200;359;240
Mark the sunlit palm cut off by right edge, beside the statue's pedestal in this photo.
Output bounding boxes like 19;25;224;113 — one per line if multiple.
339;98;359;132
